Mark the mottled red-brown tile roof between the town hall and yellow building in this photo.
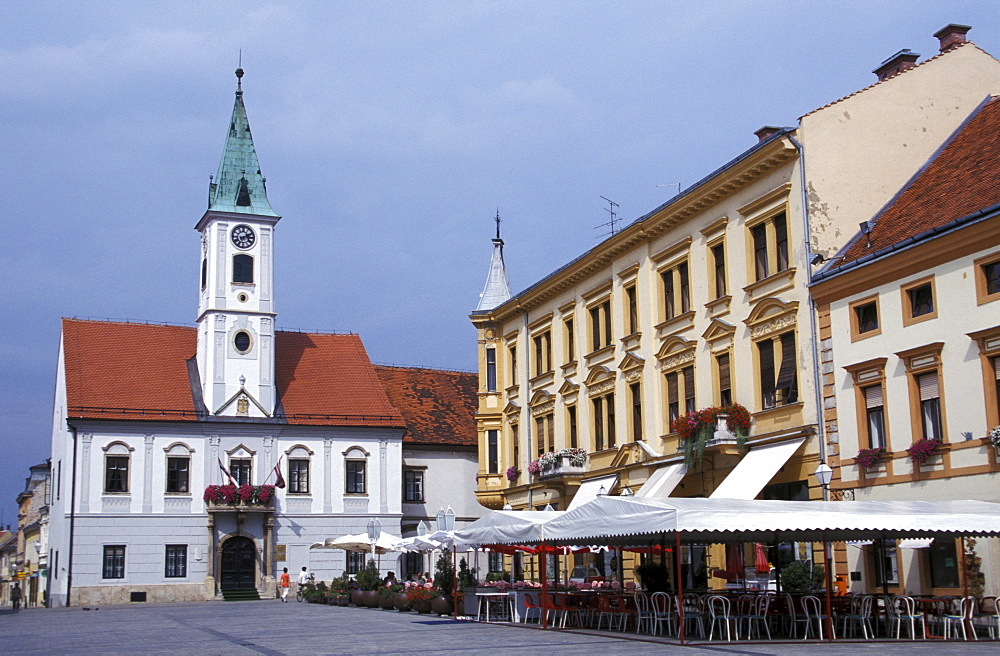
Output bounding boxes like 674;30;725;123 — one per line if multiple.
375;365;479;446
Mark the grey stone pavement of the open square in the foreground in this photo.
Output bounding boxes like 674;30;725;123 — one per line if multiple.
0;601;1000;656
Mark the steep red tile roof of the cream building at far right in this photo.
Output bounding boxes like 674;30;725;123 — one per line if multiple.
836;98;1000;267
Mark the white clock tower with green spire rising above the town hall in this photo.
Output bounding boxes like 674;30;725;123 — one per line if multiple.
195;68;281;417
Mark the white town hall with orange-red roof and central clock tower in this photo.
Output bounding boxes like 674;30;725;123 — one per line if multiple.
49;70;480;606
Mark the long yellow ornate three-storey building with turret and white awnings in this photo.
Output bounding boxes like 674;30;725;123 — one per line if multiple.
471;26;1000;580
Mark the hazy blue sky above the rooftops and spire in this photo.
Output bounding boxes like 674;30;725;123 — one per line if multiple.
0;0;1000;524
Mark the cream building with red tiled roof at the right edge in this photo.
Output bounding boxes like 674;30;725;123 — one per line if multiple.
813;92;1000;595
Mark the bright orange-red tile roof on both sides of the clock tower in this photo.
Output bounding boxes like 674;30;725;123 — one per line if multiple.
63;319;404;427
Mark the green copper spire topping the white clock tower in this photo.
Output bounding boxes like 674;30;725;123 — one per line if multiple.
208;68;278;216
